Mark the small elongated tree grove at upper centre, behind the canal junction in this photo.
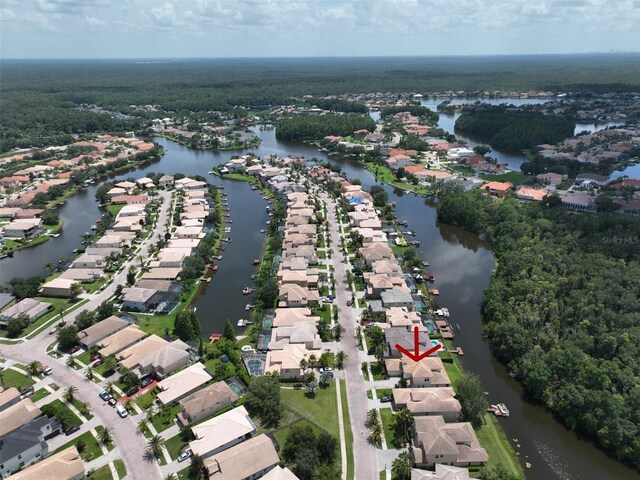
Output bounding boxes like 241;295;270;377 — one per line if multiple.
276;114;376;140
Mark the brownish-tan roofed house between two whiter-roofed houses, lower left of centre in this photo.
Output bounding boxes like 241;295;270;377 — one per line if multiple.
177;381;240;427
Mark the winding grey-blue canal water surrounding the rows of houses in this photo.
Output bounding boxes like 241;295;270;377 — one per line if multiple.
0;124;638;480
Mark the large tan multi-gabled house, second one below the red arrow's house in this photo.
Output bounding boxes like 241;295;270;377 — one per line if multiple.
411;416;489;467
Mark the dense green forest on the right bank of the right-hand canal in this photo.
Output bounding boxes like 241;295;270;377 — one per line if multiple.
438;189;640;468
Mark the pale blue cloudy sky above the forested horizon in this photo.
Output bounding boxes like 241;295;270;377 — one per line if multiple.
0;0;640;58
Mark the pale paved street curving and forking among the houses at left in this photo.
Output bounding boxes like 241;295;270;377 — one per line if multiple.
0;191;170;480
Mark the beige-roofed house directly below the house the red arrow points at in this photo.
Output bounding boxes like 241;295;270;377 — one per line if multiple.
393;387;462;422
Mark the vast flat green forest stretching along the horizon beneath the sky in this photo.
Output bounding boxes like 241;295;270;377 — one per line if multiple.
0;54;640;152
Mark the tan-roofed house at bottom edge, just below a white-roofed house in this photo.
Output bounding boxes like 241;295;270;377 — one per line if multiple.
204;434;280;480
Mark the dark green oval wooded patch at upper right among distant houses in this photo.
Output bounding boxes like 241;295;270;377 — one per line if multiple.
455;105;575;152
